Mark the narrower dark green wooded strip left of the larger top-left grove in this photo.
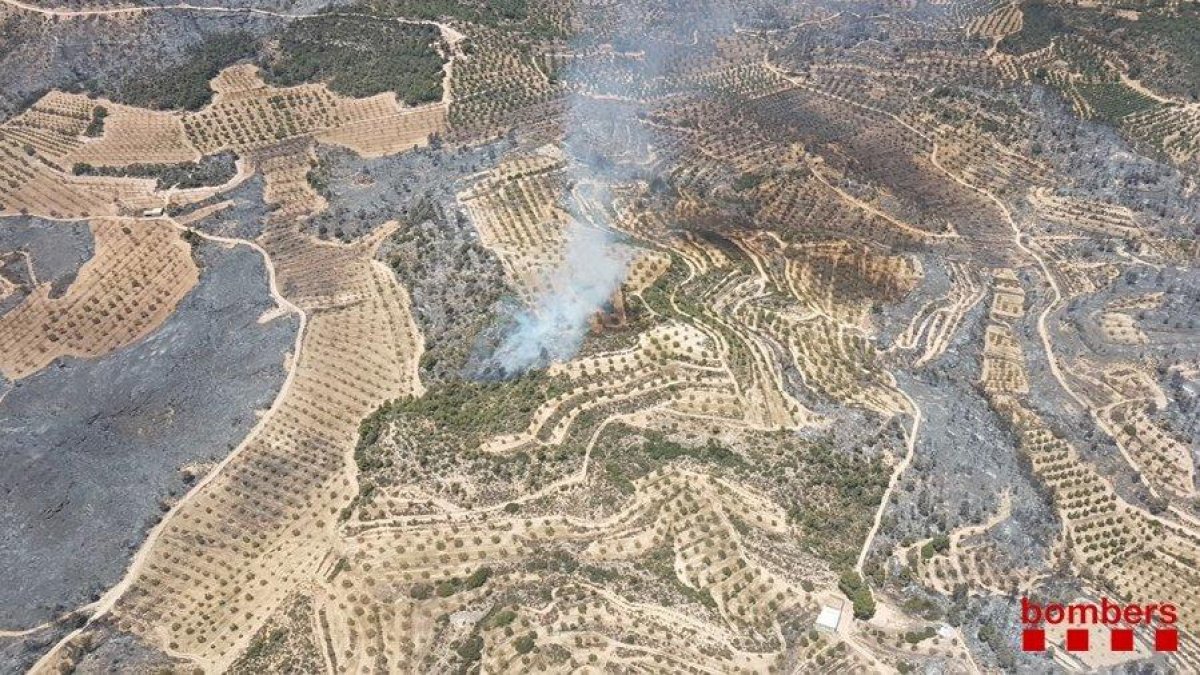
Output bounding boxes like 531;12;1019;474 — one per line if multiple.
120;32;258;110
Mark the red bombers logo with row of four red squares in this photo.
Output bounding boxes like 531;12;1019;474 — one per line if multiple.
1021;598;1180;652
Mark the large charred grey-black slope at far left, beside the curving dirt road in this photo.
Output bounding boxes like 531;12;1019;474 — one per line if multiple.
0;243;296;629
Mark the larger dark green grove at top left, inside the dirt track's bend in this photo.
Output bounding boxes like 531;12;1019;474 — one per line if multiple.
266;14;443;104
